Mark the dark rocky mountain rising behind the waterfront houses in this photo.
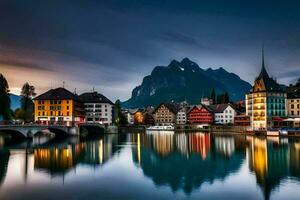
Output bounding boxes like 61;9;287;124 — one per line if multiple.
122;58;251;108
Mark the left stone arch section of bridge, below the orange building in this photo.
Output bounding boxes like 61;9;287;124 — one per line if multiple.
0;125;79;138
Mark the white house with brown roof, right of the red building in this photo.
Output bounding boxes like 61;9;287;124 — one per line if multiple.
210;104;236;124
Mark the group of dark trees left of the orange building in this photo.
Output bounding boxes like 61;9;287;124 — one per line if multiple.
0;74;36;122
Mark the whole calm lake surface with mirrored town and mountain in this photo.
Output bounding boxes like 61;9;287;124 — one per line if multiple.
0;133;300;200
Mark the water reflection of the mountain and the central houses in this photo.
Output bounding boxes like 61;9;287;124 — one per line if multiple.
133;133;245;193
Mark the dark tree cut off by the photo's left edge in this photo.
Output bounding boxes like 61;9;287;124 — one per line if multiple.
0;74;11;120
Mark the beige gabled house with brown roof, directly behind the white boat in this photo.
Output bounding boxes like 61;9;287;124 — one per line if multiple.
153;103;178;125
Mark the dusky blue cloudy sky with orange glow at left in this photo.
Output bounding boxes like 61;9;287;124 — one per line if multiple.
0;0;300;101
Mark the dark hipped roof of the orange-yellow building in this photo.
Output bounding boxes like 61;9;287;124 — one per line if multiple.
34;87;78;100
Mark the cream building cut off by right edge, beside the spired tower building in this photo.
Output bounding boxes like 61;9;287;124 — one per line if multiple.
287;78;300;118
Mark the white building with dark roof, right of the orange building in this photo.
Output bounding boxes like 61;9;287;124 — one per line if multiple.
79;92;114;124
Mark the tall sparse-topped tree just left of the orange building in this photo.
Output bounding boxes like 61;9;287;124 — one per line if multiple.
21;83;36;121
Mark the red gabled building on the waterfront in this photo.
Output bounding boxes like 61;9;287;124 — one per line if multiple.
187;105;214;124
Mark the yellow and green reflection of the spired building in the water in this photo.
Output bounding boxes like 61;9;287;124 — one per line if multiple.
248;138;300;199
